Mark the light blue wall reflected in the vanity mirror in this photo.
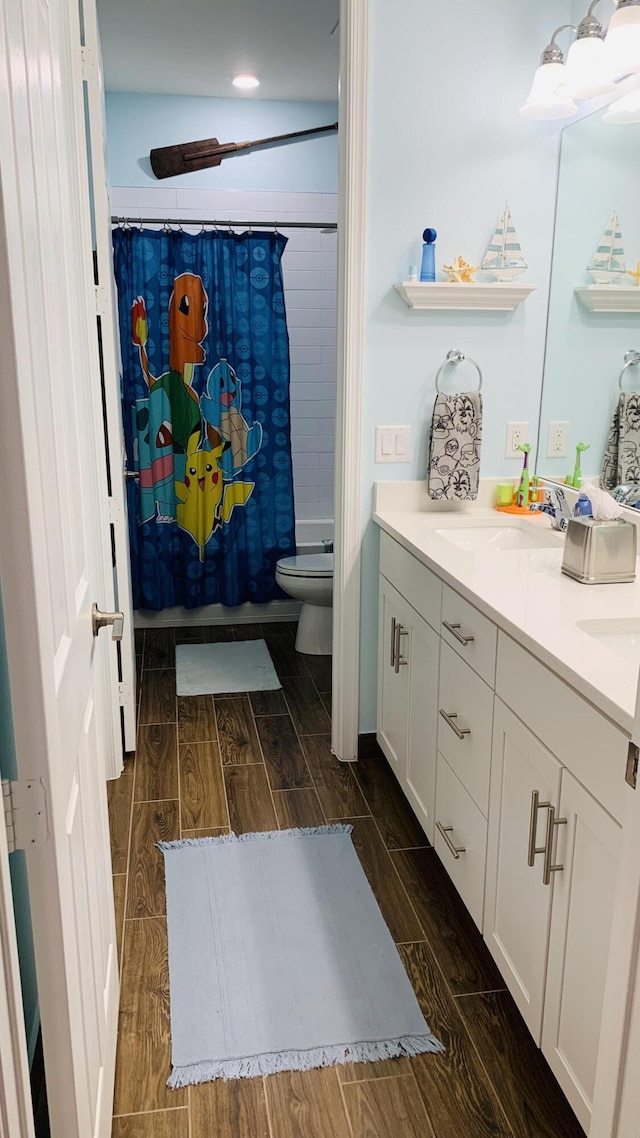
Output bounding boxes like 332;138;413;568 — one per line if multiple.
538;112;640;478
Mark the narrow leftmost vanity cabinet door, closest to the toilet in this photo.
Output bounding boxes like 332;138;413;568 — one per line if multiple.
378;577;409;783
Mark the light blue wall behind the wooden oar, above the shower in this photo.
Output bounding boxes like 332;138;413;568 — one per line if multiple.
106;91;338;193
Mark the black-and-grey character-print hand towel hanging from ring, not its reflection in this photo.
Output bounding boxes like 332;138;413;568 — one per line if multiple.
428;391;482;502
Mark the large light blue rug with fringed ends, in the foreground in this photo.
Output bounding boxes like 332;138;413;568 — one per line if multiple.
159;825;443;1087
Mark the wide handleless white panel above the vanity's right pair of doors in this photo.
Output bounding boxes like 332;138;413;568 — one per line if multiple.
495;632;629;823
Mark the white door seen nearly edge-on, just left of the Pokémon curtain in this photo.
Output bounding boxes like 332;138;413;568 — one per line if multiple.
81;0;136;755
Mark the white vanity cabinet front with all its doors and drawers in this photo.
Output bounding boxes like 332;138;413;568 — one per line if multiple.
377;533;627;1131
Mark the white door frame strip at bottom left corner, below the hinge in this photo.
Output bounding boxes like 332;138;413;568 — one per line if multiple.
0;819;33;1138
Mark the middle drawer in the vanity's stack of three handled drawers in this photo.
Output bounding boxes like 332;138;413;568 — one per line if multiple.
437;643;493;817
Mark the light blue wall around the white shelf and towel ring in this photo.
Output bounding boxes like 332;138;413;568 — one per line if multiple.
360;0;571;731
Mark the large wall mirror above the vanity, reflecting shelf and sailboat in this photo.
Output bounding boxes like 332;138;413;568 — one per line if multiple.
538;93;640;493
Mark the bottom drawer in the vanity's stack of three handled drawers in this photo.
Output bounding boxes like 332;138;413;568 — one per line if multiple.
434;754;486;930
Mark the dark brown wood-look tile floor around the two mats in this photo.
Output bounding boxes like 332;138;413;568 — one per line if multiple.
108;625;582;1138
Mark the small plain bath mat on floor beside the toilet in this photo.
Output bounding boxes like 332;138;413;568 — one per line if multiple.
175;641;281;695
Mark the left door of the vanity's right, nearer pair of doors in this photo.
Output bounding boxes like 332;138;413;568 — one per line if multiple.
484;699;560;1045
